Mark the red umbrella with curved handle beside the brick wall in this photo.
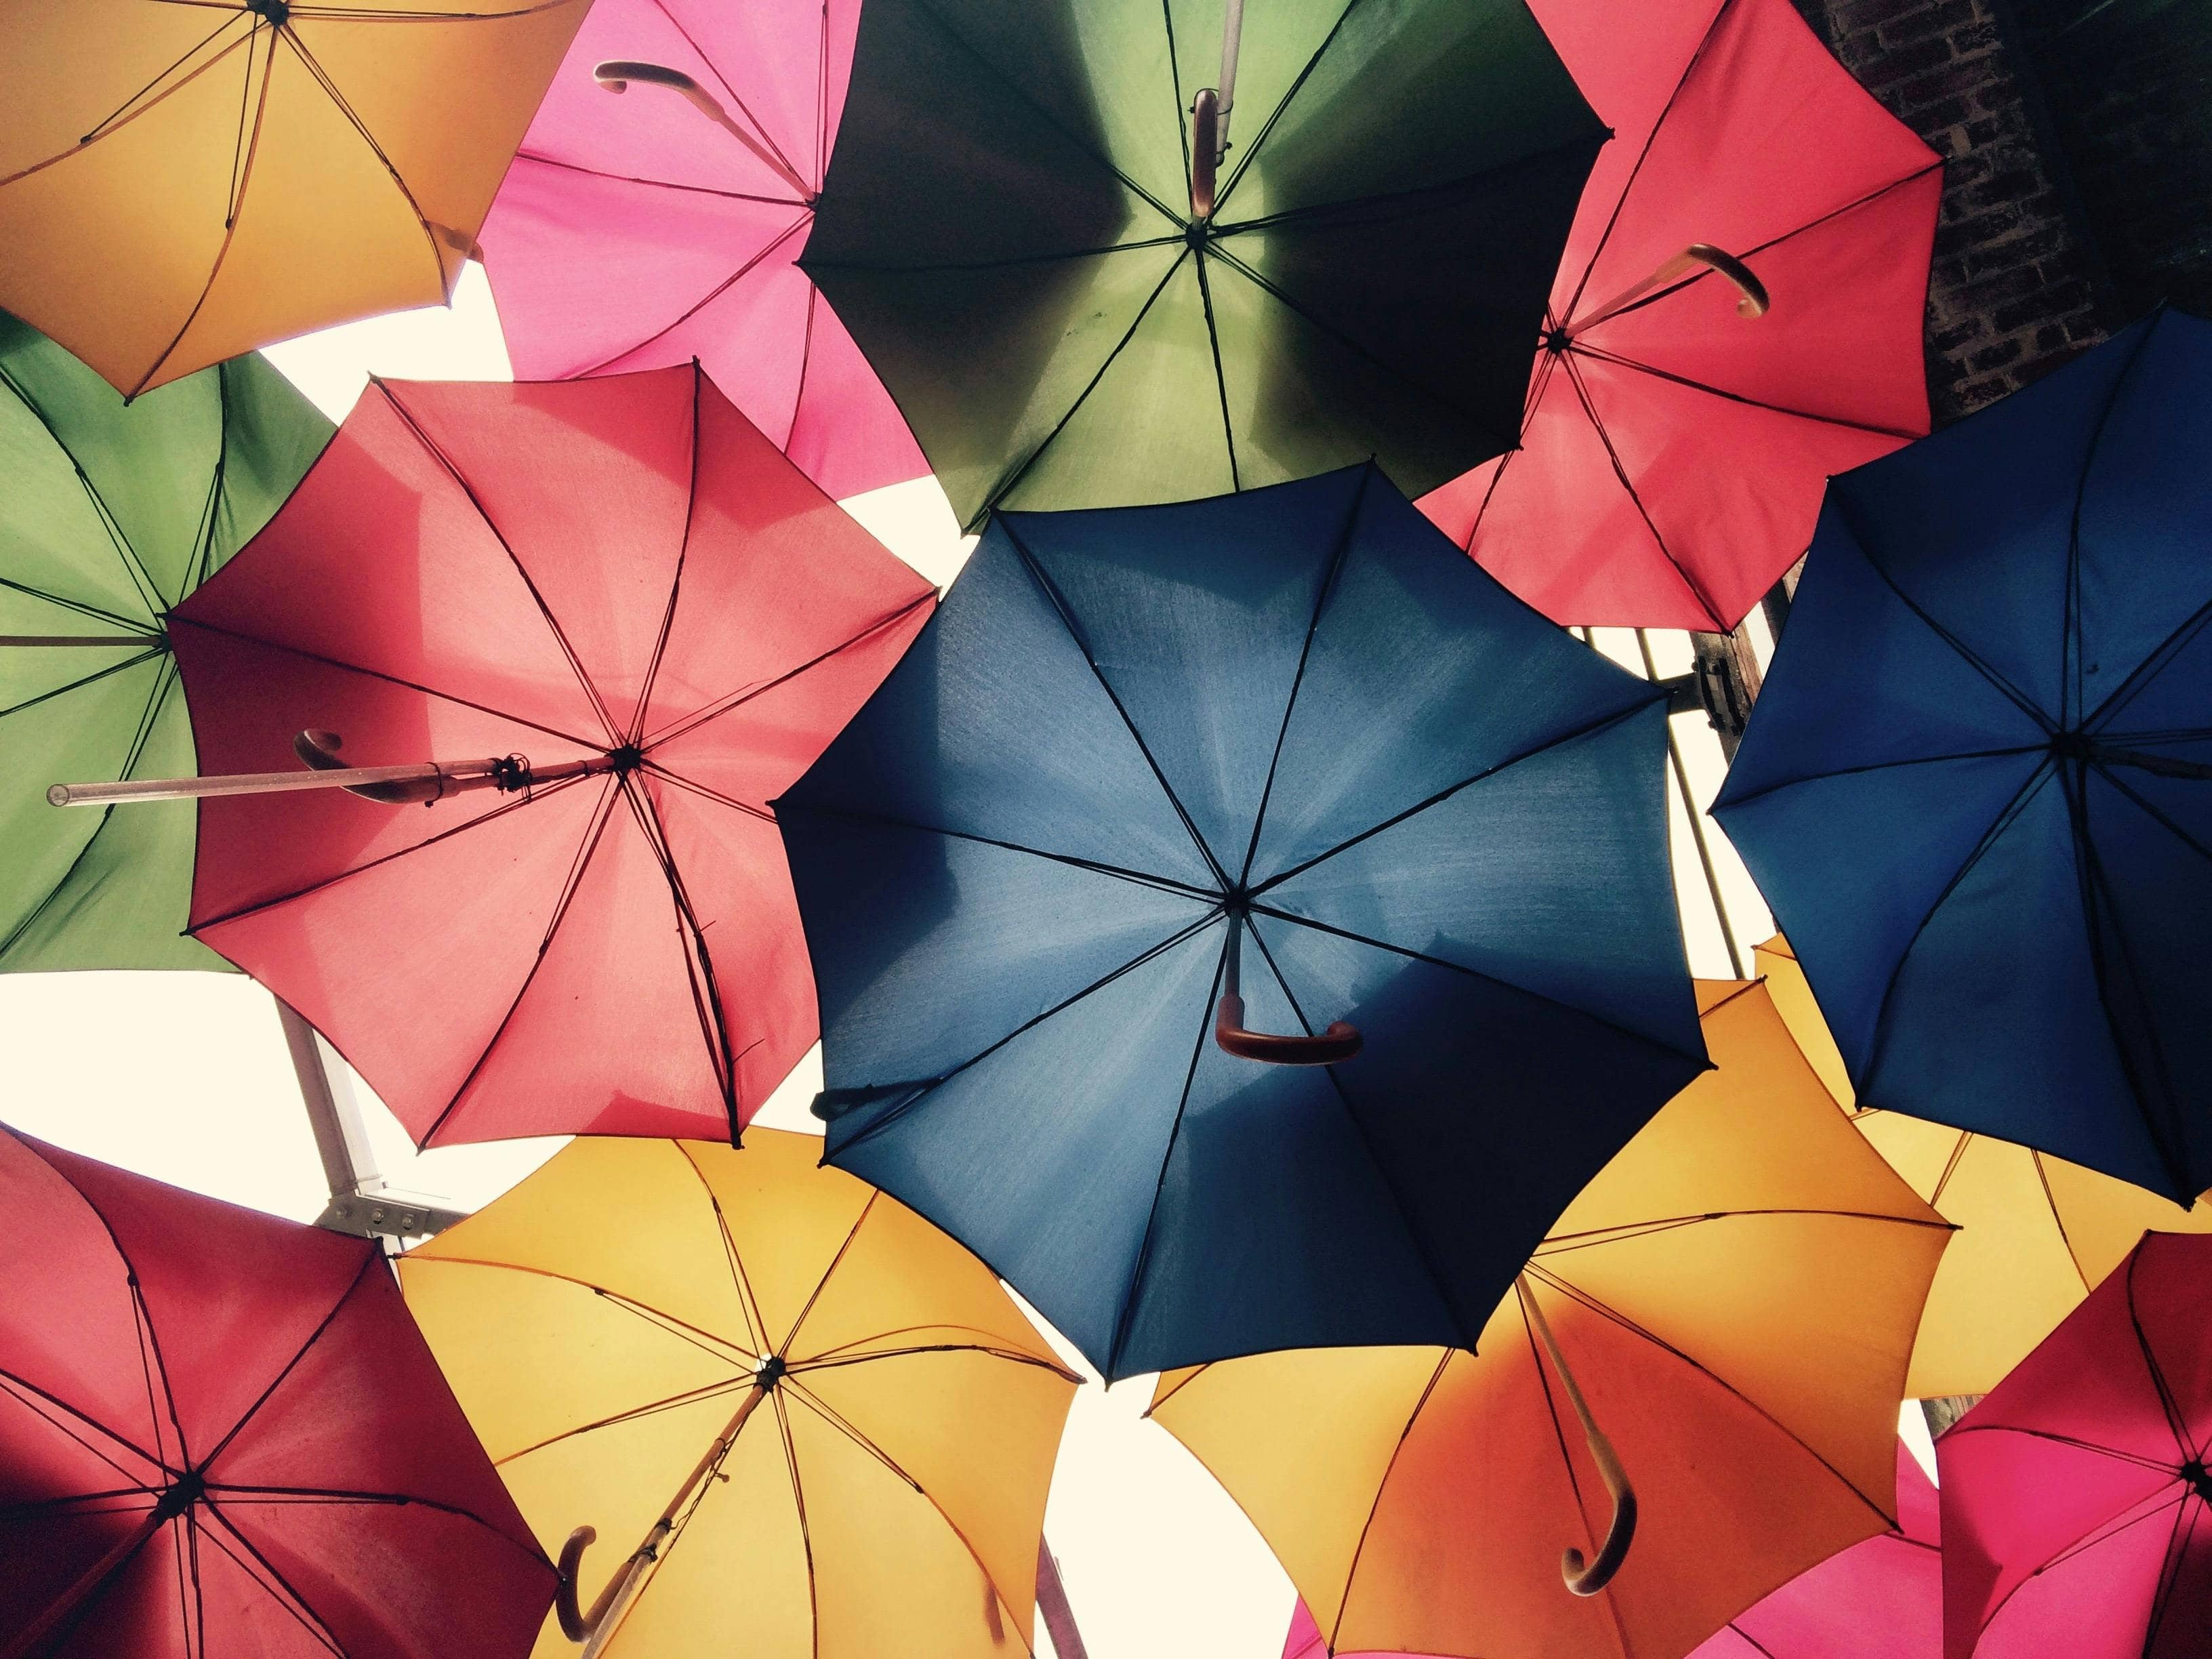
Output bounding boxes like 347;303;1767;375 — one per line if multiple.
1420;0;1942;628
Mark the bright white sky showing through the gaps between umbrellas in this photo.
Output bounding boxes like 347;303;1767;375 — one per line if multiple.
0;266;1933;1659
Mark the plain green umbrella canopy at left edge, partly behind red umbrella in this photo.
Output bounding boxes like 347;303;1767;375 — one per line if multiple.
0;314;329;969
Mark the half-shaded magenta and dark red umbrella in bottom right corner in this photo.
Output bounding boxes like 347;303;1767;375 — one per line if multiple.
1936;1232;2212;1659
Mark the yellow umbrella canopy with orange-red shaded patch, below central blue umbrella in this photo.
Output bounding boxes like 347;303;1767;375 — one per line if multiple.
1153;982;1949;1659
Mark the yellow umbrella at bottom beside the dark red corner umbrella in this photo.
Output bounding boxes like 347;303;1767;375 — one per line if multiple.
401;1128;1078;1659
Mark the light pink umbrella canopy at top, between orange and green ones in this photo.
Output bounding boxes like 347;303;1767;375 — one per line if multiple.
483;0;929;495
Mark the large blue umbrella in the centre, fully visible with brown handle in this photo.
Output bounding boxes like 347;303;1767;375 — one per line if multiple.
777;464;1706;1376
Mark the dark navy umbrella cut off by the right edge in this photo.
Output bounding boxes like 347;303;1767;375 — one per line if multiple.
1717;312;2212;1204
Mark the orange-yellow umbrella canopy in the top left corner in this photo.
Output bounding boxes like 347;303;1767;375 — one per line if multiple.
0;0;588;394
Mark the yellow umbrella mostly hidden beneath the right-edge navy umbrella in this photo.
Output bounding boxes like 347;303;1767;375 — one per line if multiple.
1754;936;2212;1400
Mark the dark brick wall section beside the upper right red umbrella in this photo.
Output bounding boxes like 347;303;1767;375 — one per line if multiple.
1796;0;2117;425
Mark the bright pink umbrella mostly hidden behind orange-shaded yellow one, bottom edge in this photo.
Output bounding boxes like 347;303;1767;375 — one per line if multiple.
1283;1442;1942;1659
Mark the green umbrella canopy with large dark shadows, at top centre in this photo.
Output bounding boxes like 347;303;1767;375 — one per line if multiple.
803;0;1606;529
